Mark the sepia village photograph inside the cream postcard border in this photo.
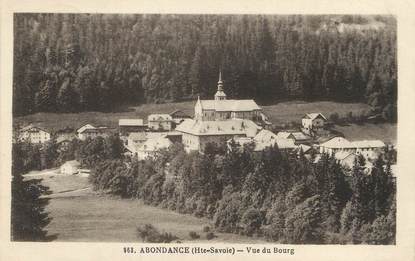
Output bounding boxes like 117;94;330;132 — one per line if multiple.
10;12;400;245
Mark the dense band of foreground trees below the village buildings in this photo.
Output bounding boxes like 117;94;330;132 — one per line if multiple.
90;141;396;244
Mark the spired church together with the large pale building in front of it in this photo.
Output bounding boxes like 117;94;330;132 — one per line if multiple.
176;73;264;152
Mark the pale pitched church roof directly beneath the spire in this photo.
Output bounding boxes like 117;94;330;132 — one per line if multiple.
200;100;261;111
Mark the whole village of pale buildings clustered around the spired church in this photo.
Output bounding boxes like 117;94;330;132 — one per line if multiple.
15;73;389;175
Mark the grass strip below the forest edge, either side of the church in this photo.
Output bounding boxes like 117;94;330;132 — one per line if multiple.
14;101;369;131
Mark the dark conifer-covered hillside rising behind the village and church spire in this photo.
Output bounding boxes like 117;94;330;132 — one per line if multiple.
13;14;397;120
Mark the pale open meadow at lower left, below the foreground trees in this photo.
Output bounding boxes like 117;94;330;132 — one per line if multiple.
46;194;264;243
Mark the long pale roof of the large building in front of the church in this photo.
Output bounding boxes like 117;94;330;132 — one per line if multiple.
176;119;261;137
